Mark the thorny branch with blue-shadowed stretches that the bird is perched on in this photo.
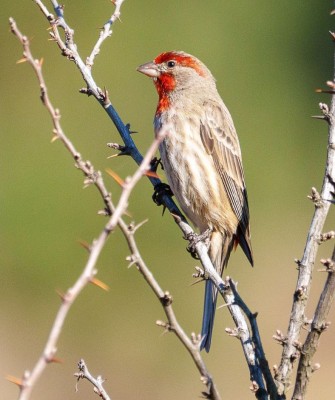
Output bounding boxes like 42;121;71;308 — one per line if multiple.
21;0;271;398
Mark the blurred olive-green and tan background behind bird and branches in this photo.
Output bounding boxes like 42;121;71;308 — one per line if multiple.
0;0;335;400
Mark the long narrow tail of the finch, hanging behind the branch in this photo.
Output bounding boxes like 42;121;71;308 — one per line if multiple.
200;232;235;352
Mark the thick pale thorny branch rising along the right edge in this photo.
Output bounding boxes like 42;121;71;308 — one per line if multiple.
275;18;335;399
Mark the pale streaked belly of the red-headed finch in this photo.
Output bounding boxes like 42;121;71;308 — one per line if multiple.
160;137;237;232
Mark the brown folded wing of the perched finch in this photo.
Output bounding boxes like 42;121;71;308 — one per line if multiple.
200;103;253;264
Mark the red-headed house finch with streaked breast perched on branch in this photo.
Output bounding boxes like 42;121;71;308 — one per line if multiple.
137;51;253;351
